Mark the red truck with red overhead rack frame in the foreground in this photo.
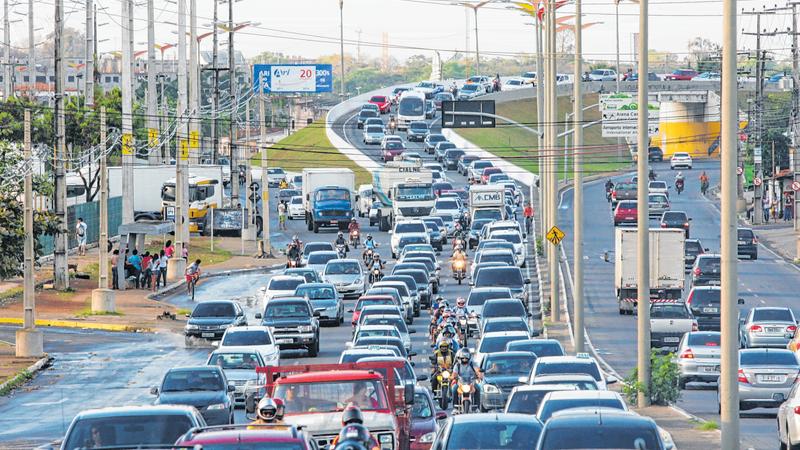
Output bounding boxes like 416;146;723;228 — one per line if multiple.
253;361;414;450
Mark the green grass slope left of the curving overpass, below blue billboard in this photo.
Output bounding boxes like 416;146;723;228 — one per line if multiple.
252;118;372;186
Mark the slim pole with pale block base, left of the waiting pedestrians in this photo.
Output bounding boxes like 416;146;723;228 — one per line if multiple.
92;106;116;312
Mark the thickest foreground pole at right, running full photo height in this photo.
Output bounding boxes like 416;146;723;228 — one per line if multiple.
720;0;740;444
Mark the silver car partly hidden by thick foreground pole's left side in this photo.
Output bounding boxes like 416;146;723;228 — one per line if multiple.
676;331;720;389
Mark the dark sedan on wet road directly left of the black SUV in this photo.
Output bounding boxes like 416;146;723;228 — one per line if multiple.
183;300;247;345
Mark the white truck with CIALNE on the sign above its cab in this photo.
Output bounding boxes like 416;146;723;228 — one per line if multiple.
372;161;436;231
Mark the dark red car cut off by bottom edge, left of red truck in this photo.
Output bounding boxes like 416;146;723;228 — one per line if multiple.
175;424;317;450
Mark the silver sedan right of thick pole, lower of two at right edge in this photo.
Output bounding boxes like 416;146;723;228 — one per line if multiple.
717;348;800;411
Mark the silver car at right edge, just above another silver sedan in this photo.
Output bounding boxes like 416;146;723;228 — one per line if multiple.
739;307;797;348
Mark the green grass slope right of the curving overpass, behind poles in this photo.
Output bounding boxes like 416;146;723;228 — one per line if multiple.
457;94;631;179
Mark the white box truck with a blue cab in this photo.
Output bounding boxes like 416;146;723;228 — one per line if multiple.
303;168;356;233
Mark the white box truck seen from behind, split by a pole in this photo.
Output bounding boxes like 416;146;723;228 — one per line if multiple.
614;228;686;314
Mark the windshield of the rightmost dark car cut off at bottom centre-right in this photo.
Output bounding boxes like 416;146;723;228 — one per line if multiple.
539;426;663;450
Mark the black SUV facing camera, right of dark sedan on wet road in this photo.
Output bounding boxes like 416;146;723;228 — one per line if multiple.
256;298;320;357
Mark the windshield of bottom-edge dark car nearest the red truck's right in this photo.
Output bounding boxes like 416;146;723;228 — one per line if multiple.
447;419;542;450
